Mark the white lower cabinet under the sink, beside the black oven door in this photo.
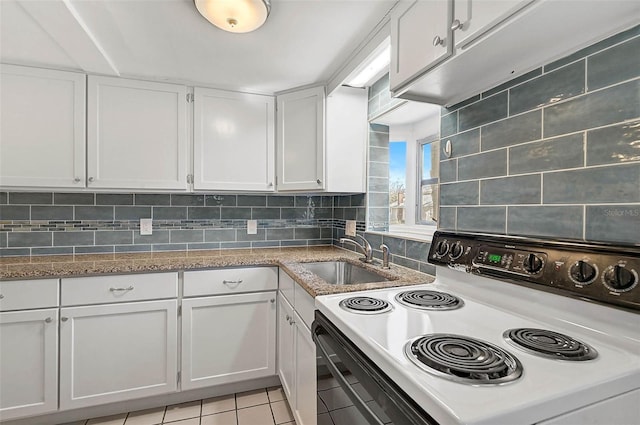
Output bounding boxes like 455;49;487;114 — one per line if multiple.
278;271;317;425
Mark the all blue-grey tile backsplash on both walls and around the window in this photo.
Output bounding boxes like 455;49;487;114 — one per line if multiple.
0;27;640;273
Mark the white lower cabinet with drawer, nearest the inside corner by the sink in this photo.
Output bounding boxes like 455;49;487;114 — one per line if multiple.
182;267;278;390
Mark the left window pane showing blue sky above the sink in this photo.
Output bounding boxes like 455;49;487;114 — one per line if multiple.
389;142;407;224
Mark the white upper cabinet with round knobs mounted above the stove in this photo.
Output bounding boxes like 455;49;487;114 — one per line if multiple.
390;0;640;105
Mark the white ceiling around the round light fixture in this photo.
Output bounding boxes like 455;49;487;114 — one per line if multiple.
0;0;396;93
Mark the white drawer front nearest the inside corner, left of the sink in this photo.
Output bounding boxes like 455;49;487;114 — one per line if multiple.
184;267;278;297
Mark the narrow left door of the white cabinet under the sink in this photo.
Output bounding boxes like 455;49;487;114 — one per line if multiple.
278;293;296;407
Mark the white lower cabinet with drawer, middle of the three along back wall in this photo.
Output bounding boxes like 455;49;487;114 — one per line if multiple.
60;273;178;410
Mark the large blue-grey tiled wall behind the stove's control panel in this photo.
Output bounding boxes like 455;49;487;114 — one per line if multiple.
439;26;640;243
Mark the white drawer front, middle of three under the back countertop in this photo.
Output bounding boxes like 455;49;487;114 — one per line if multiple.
62;273;178;306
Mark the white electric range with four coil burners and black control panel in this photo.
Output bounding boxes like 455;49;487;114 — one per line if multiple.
314;232;640;425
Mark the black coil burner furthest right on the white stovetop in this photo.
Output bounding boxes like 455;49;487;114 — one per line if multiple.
502;328;598;361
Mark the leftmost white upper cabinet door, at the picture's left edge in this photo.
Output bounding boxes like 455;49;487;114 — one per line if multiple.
0;65;85;188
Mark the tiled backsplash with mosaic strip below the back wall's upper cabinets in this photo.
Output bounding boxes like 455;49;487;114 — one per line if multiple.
0;192;340;256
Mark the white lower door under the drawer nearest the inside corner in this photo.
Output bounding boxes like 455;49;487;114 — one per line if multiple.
182;291;276;390
